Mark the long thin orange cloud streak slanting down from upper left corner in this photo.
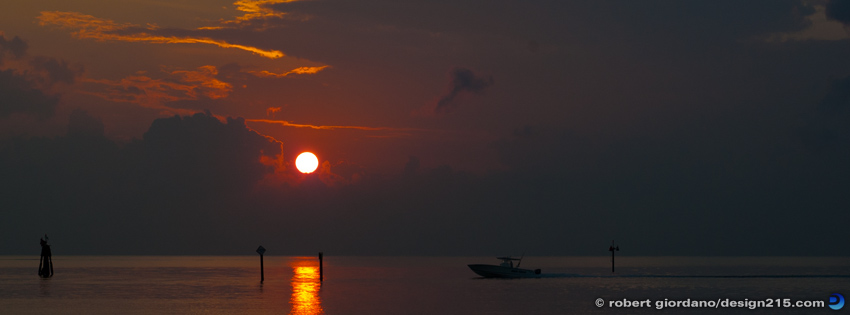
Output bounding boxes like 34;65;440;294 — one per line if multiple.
38;11;284;59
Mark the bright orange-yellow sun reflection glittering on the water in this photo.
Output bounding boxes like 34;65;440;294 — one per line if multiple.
289;260;325;315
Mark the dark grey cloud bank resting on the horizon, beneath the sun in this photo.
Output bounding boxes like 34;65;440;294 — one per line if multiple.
0;99;850;255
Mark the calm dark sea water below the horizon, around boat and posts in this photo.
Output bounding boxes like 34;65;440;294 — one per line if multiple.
0;255;850;315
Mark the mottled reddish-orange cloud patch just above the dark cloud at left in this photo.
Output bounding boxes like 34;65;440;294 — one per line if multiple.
81;66;233;113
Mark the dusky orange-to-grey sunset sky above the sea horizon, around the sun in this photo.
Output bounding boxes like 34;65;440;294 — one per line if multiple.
0;0;850;256
